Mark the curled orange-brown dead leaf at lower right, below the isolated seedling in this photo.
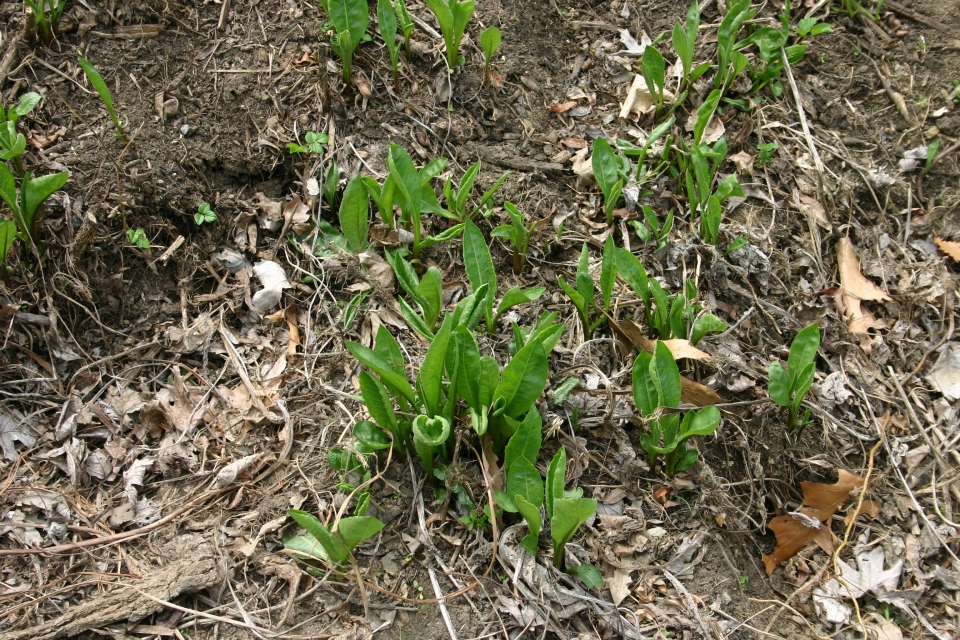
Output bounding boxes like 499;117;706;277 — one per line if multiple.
763;469;864;574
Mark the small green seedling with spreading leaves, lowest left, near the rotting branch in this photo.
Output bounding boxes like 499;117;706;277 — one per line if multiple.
283;508;383;569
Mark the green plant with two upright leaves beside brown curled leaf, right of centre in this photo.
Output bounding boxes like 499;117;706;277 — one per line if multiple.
633;340;720;478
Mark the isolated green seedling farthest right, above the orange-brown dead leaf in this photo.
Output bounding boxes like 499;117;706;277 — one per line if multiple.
768;324;820;435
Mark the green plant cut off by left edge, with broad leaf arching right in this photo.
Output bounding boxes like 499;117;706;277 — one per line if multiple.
0;163;70;261
